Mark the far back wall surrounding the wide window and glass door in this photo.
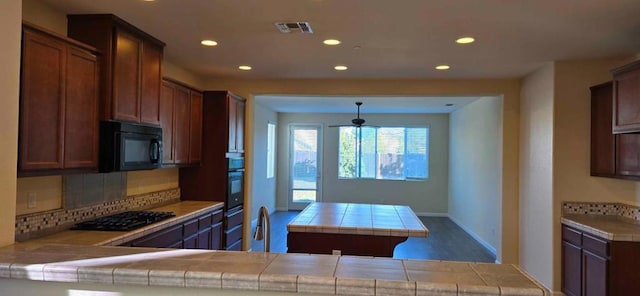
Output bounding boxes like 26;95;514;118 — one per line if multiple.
277;113;449;214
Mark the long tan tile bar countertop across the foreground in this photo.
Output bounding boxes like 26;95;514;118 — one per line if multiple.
0;244;548;296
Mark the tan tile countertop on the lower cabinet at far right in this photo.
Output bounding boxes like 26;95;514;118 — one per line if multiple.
561;214;640;241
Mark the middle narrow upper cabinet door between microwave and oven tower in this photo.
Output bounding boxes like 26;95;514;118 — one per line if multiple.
173;86;191;164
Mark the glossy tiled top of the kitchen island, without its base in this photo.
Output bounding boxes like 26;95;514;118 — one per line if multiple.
287;202;429;237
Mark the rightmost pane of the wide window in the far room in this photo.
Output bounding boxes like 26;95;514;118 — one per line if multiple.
405;128;429;179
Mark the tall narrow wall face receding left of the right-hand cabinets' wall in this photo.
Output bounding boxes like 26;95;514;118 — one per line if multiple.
519;64;554;288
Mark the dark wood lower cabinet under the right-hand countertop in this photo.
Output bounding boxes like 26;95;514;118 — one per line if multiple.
562;225;640;296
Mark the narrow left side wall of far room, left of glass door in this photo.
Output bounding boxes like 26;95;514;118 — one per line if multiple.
249;104;278;221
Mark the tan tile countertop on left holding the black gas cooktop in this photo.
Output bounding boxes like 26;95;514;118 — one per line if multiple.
13;201;224;247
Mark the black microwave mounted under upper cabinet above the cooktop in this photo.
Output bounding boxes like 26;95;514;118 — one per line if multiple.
99;121;162;173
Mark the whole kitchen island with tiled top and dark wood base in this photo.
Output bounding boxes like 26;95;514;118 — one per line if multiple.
287;202;429;257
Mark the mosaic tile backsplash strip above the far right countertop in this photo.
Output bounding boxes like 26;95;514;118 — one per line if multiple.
562;202;640;221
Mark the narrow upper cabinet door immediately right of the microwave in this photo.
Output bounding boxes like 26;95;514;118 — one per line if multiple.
160;82;176;164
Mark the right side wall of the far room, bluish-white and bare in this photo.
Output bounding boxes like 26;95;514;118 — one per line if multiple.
449;97;502;253
